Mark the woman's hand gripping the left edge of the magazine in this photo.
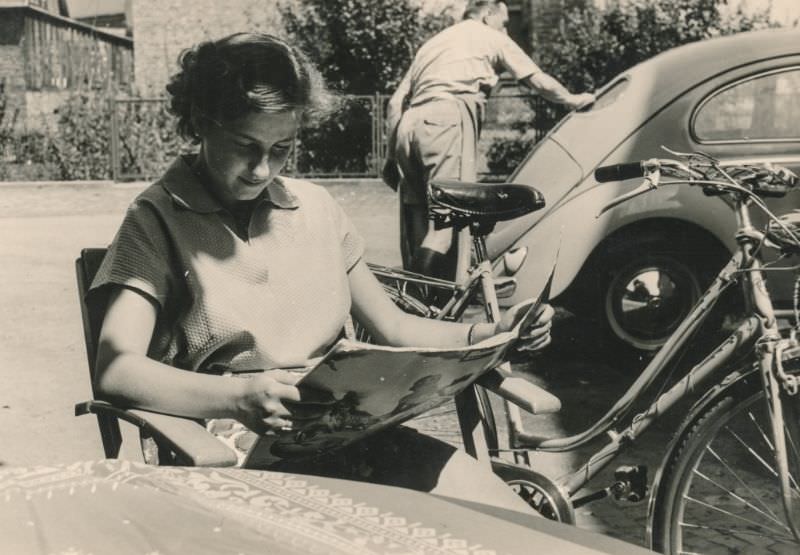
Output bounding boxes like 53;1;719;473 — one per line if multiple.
236;370;302;434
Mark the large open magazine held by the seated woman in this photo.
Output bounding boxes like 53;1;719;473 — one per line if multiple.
244;262;553;468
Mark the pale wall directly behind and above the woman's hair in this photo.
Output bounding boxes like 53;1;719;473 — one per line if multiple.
131;0;300;96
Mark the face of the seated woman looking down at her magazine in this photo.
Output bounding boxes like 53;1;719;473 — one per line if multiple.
200;112;297;206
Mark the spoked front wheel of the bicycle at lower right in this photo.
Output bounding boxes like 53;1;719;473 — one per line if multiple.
650;349;800;555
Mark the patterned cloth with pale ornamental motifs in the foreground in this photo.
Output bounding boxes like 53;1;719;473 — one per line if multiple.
0;460;552;555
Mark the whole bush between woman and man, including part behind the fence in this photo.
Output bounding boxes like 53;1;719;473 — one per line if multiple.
282;0;452;174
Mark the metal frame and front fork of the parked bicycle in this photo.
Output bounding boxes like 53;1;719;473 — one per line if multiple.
373;173;800;538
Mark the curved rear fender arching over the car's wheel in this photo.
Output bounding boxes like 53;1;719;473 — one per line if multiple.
496;177;736;305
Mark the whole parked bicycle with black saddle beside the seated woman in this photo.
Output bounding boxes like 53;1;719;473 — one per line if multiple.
360;151;800;553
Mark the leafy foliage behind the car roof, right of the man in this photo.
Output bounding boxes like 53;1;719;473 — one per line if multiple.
537;0;775;90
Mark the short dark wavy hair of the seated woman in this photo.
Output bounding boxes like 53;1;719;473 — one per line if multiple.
167;33;335;141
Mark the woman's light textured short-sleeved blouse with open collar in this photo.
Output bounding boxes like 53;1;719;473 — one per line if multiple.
90;157;364;373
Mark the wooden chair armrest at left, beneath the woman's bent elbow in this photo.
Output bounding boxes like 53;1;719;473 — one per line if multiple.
75;401;237;466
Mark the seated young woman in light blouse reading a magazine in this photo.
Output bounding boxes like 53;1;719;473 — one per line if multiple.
91;33;552;508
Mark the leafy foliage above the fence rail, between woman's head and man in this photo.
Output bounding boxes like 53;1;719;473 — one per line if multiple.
282;0;452;94
